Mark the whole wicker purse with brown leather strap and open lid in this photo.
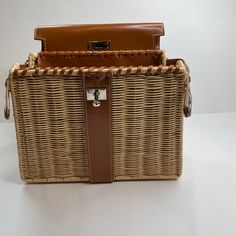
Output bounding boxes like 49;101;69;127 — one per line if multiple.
5;23;191;183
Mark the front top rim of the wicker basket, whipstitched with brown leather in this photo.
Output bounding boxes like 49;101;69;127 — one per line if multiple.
13;63;186;78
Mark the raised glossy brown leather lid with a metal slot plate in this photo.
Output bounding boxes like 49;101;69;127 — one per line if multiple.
34;23;164;51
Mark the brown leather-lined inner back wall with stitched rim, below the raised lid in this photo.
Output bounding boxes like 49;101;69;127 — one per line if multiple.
36;50;164;68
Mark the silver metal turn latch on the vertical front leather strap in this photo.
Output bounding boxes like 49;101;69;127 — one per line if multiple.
86;88;107;107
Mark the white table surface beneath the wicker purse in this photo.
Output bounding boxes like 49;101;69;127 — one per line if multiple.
0;113;236;236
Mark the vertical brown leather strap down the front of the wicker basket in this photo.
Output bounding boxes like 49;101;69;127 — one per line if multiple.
83;74;113;183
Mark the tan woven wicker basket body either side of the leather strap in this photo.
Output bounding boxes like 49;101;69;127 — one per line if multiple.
6;50;189;182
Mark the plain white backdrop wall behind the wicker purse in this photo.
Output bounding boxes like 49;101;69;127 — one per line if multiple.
0;0;236;121
